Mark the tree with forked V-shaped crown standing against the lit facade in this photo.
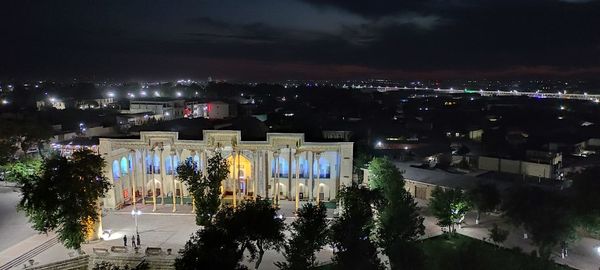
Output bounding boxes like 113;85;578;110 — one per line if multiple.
177;152;229;226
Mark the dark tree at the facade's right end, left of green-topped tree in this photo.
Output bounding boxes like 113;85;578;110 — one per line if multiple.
330;183;383;269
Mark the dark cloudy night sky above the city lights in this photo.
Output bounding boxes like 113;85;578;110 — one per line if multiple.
0;0;600;80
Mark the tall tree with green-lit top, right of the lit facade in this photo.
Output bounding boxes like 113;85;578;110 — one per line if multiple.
369;158;425;269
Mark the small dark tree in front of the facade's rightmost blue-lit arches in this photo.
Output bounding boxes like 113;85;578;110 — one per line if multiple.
276;202;329;270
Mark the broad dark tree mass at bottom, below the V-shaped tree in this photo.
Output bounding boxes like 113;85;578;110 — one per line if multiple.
175;200;284;269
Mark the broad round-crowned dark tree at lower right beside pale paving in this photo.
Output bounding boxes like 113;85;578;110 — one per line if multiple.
503;186;576;258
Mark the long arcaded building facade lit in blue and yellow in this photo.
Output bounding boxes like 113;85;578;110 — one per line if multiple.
99;130;353;211
